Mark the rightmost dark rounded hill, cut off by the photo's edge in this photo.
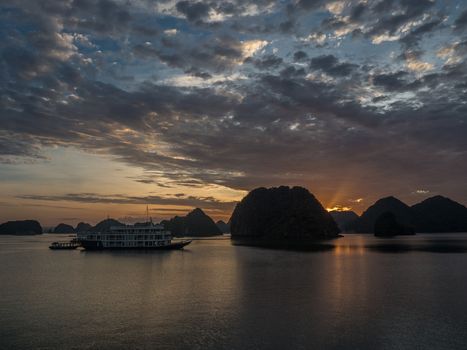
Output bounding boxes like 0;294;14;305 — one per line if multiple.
411;196;467;232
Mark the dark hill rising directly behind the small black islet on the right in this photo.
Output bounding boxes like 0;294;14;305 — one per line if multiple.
351;197;413;233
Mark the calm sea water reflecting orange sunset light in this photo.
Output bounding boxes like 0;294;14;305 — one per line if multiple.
0;234;467;349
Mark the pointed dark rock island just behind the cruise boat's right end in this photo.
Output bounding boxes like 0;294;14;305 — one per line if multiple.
161;208;222;237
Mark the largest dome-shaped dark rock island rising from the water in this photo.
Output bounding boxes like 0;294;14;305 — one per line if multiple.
230;186;339;244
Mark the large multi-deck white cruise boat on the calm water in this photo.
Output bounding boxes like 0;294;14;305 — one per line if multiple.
77;222;191;250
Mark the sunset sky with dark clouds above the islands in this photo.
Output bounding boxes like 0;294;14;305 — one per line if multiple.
0;0;467;225
